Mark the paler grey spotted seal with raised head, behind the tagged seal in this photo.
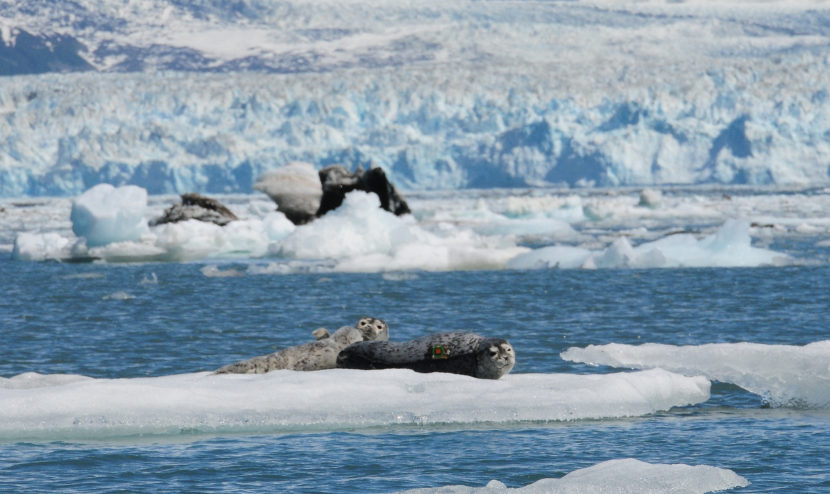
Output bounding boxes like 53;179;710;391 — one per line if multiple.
215;317;389;374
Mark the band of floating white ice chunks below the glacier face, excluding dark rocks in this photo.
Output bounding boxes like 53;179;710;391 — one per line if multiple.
0;186;830;276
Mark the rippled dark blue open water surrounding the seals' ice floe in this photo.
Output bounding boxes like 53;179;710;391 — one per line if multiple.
0;259;830;492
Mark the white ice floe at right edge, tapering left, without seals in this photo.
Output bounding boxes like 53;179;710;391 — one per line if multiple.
562;340;830;408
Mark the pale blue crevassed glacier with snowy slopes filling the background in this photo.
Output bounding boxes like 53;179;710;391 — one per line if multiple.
0;0;830;197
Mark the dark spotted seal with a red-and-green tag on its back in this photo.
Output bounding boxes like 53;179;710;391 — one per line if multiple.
337;331;516;379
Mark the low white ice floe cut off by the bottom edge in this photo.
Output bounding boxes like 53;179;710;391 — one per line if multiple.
405;458;749;494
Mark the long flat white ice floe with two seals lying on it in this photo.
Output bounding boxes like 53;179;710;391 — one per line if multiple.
0;369;709;439
